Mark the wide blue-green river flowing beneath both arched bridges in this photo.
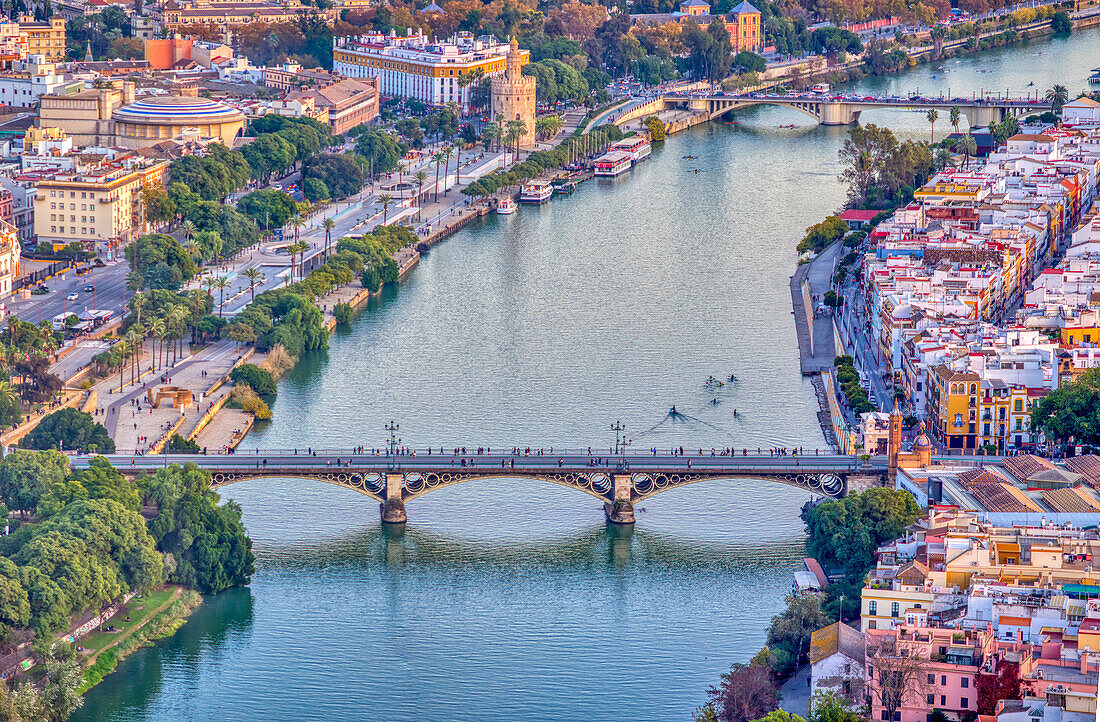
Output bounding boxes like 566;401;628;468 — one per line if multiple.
74;31;1100;722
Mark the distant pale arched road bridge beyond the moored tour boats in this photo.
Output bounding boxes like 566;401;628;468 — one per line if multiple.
663;94;1049;128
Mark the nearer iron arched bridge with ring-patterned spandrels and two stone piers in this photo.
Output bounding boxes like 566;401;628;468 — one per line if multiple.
73;449;888;523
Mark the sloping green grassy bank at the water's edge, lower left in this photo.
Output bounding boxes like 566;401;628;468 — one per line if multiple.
77;586;202;694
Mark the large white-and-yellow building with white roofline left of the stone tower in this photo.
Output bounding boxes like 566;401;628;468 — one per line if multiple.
332;33;519;112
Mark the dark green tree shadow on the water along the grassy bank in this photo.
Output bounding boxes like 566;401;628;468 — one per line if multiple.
69;588;253;722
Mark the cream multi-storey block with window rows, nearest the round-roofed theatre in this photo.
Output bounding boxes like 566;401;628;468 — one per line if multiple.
34;161;168;248
